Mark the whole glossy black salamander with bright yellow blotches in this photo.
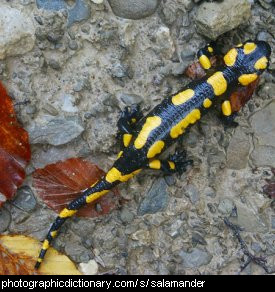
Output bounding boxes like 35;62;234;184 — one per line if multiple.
35;41;271;268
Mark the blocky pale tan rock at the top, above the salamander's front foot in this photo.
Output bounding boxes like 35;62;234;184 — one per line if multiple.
196;0;251;40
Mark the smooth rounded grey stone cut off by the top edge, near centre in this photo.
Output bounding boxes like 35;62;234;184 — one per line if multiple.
108;0;159;19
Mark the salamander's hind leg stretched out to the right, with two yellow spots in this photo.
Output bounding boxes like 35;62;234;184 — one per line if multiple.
147;151;193;174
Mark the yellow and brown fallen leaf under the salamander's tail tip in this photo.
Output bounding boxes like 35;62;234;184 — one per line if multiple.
0;235;81;275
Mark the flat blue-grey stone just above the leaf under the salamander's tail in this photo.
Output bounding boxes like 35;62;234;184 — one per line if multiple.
27;117;84;146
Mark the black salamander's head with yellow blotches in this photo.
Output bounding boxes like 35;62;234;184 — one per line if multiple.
224;41;271;85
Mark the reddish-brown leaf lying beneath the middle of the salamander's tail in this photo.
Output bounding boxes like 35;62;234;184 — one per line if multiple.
33;158;119;217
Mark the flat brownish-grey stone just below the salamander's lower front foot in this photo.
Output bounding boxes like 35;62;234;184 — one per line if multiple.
227;127;250;169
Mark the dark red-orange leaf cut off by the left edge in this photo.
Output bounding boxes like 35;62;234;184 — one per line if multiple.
0;83;31;207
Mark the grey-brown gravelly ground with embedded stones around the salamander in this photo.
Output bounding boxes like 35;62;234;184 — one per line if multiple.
0;0;275;274
